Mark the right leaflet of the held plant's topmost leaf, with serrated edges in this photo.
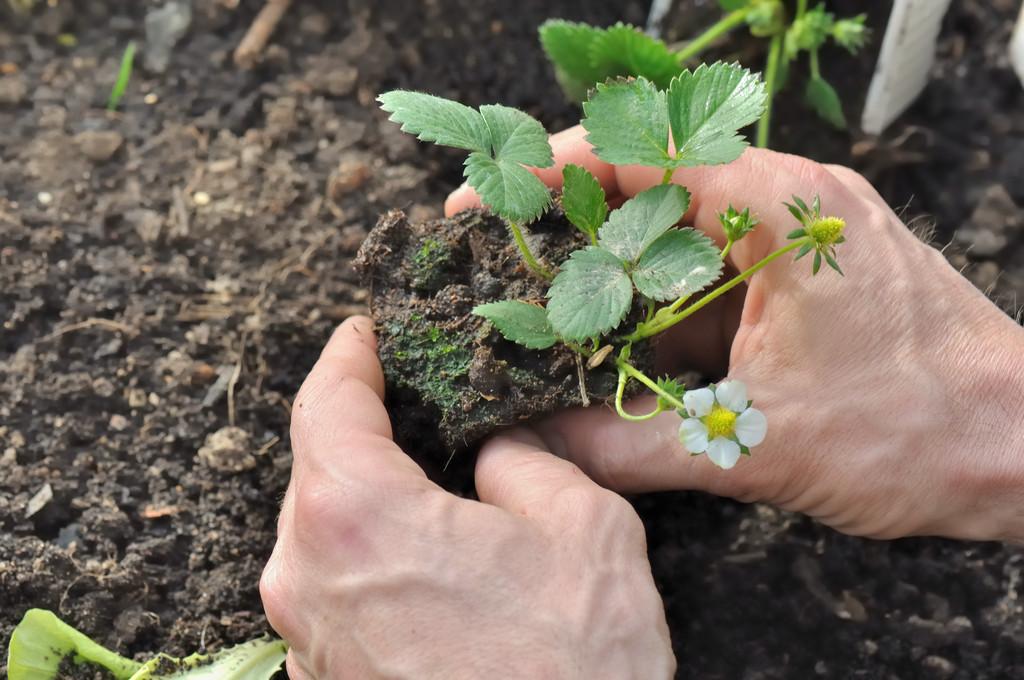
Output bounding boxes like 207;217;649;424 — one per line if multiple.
668;62;767;167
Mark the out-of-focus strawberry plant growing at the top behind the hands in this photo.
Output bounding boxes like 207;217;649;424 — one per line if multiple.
540;0;868;146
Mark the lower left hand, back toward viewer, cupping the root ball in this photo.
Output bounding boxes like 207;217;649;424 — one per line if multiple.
260;317;675;680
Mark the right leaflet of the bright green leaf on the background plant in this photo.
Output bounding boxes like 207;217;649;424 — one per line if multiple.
590;23;681;88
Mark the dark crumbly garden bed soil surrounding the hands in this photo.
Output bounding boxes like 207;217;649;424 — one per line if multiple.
0;0;1024;680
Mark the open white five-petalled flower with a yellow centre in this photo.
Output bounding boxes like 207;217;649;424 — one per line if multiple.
679;380;768;470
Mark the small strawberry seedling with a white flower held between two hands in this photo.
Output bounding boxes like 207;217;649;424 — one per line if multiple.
380;62;845;468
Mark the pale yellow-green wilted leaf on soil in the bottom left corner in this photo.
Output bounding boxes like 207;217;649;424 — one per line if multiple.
7;609;288;680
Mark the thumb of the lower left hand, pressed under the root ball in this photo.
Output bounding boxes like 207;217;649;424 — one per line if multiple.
475;428;622;521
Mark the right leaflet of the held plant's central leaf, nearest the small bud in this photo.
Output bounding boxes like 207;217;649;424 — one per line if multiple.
633;228;722;301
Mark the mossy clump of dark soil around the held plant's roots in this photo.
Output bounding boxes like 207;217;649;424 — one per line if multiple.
355;205;653;454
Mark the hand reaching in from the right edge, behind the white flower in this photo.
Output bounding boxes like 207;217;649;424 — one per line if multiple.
445;127;1024;539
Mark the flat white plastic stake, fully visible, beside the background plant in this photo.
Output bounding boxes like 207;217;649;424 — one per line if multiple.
860;0;950;134
